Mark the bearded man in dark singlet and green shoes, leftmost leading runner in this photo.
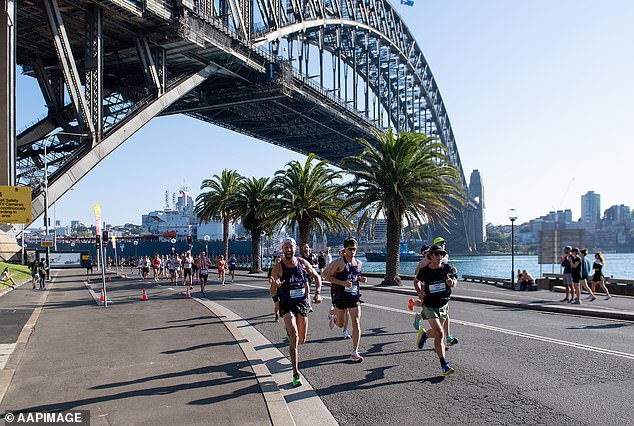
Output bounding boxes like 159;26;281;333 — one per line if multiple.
270;238;321;387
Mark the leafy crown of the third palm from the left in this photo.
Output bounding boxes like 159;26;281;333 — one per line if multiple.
272;154;351;247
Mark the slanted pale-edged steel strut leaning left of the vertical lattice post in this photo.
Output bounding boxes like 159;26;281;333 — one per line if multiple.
43;0;95;141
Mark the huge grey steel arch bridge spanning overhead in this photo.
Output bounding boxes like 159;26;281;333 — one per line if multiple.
16;0;473;251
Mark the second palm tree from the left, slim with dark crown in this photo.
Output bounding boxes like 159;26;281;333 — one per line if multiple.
230;177;275;273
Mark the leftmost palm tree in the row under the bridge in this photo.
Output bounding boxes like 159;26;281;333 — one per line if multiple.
194;169;243;259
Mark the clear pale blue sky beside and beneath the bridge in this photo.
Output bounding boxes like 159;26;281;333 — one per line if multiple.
17;0;634;230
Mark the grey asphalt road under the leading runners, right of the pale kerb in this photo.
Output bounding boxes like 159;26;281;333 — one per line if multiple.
202;276;634;425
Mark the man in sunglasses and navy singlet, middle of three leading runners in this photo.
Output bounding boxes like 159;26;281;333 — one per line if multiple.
322;238;367;362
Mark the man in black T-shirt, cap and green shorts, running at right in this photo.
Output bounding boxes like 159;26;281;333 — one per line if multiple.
414;245;458;376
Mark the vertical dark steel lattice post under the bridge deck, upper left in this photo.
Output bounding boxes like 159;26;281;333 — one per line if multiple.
85;4;103;143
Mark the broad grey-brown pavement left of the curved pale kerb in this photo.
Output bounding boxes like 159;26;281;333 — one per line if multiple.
0;270;271;425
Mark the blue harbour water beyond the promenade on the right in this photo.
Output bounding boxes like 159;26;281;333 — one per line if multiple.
361;253;634;279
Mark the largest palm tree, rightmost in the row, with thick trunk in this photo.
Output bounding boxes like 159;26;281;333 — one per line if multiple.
342;130;464;285
